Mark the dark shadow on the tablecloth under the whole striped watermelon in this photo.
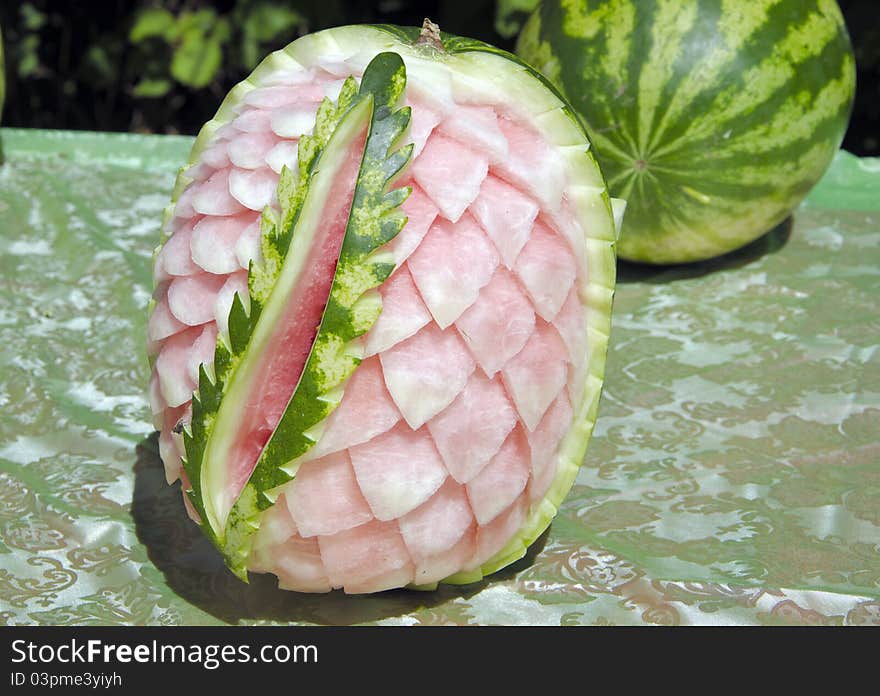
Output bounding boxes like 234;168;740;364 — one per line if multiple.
617;215;794;283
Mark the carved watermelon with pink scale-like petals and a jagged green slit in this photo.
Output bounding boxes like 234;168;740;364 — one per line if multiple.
148;24;615;592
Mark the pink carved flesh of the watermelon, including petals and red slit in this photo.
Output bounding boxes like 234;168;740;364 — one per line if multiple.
149;62;586;592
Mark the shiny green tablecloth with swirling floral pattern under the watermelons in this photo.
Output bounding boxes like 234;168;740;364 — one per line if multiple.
0;129;880;624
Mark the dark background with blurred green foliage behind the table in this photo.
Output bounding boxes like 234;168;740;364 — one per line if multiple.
0;0;880;155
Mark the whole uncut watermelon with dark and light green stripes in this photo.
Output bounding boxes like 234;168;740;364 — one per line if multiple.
517;0;855;264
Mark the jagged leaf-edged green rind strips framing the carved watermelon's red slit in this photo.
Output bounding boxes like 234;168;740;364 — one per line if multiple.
184;53;412;580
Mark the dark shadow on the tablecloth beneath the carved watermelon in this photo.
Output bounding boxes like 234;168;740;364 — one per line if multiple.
131;433;547;625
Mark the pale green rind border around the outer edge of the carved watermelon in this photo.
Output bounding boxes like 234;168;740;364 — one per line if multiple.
156;25;617;584
